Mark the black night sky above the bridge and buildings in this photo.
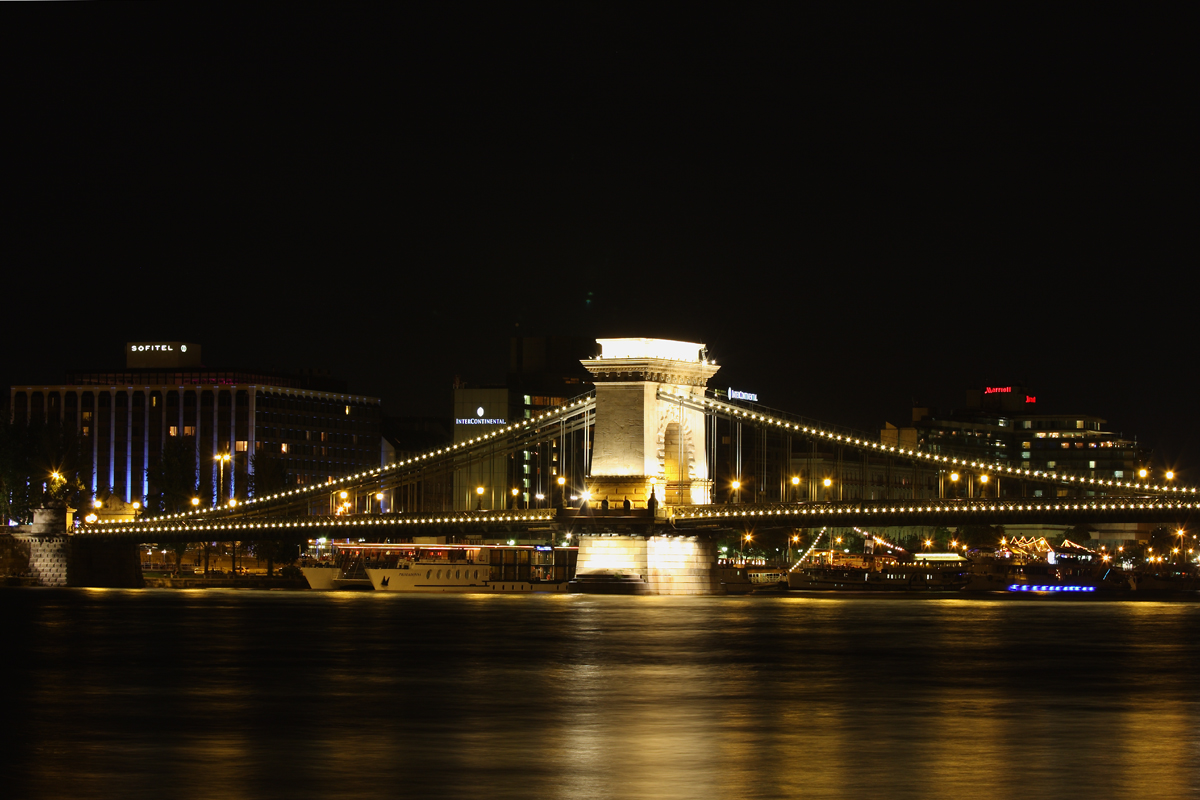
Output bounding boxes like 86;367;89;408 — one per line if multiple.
0;10;1200;471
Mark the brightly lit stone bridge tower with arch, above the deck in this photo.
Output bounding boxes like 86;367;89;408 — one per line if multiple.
582;338;719;507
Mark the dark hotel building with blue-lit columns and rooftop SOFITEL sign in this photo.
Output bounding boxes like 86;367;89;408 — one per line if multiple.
10;342;382;503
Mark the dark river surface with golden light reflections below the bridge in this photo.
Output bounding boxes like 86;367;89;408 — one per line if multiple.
0;589;1200;800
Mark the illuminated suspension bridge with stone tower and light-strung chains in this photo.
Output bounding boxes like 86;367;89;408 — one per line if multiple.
65;339;1200;591
